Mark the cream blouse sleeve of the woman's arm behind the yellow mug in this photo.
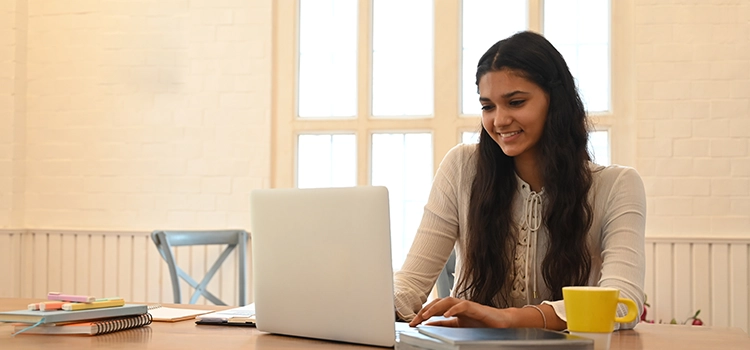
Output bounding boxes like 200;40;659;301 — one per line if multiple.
543;168;646;329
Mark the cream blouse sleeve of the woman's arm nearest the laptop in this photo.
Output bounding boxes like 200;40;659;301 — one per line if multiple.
394;144;465;320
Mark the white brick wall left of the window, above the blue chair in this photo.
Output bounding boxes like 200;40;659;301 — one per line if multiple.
13;0;272;230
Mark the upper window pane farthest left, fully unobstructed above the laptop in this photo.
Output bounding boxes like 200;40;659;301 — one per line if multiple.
299;0;357;118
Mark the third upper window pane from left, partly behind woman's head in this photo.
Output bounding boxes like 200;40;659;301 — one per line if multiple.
461;0;529;115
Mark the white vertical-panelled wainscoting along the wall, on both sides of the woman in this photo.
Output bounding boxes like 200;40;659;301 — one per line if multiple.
0;230;750;331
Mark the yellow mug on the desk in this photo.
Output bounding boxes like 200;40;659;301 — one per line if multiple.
563;287;638;333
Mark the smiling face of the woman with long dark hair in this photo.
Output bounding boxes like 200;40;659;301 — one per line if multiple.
479;69;549;161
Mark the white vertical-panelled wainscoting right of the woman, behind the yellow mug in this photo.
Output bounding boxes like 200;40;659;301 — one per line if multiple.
646;238;750;332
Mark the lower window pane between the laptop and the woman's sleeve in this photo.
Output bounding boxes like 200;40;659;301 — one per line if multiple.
371;133;433;270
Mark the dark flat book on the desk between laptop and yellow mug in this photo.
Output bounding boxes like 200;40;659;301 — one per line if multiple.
396;326;594;350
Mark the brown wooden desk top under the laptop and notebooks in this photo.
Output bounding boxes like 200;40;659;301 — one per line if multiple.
0;298;750;350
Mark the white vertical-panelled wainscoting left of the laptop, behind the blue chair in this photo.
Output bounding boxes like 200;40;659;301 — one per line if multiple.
0;230;252;304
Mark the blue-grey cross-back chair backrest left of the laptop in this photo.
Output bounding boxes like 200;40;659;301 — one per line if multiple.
151;230;249;306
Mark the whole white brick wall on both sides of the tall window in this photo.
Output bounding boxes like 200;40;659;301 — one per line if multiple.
0;0;750;235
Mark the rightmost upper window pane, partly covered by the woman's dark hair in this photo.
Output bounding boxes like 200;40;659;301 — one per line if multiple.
544;0;610;112
